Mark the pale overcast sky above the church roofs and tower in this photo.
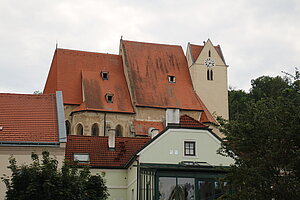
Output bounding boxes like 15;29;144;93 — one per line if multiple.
0;0;300;93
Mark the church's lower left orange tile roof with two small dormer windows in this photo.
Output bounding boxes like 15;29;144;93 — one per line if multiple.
44;49;133;112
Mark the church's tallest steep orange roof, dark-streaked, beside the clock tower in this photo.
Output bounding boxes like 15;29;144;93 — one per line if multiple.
121;40;203;110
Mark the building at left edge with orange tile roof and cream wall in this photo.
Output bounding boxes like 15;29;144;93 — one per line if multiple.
0;92;67;199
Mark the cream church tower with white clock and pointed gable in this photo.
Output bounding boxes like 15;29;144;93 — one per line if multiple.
186;39;229;119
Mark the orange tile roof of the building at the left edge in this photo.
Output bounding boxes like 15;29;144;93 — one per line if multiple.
0;94;58;142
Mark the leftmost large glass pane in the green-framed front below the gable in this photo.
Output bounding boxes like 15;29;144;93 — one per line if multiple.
158;177;176;200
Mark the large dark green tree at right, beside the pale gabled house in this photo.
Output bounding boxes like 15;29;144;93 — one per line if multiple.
219;71;300;200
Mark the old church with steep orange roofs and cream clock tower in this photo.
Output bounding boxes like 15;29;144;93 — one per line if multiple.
43;39;228;137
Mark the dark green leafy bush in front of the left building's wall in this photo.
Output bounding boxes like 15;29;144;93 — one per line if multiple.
2;151;109;200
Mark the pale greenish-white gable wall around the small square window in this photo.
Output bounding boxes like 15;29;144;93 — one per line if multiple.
138;129;234;166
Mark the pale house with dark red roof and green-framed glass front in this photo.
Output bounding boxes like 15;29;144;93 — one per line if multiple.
66;115;234;200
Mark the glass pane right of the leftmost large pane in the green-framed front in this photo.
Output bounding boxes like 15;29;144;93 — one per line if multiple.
177;178;195;200
